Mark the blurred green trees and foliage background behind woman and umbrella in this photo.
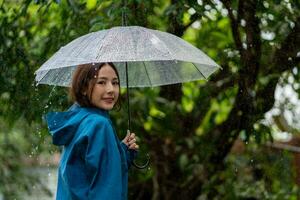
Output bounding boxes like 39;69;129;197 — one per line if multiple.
0;0;300;200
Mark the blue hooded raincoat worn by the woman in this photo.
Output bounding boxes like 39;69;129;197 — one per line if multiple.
46;104;136;200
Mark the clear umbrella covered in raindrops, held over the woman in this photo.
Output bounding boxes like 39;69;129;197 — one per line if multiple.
35;26;220;169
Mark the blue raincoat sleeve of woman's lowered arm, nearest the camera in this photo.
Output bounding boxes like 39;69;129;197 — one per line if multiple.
85;116;127;200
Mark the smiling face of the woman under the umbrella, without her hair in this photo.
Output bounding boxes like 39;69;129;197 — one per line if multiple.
91;64;120;110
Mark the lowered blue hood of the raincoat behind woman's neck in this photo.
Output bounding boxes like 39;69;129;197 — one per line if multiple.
46;103;109;146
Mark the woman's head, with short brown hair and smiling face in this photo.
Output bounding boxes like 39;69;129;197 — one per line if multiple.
70;63;120;110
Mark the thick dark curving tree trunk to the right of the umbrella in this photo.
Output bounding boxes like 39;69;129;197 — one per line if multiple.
205;0;261;165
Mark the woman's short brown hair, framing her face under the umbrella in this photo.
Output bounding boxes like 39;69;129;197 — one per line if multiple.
70;62;121;110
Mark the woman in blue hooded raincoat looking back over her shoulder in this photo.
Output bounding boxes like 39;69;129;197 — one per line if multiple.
46;63;139;200
